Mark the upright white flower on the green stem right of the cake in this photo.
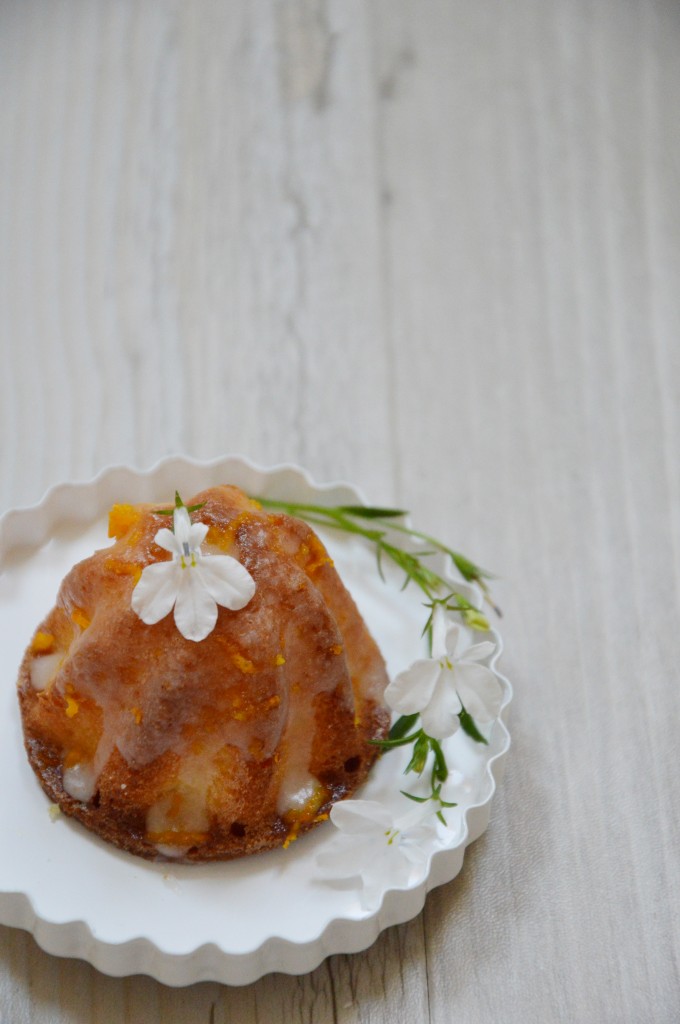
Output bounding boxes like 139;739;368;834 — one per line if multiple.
385;607;503;739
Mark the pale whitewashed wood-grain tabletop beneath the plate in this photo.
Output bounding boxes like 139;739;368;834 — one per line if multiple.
0;0;680;1024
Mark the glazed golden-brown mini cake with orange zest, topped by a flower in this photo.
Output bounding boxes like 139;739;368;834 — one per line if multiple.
18;486;389;862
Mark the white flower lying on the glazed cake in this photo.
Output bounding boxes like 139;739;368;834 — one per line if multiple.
132;505;255;641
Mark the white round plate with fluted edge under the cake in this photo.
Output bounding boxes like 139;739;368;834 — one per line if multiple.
0;457;511;985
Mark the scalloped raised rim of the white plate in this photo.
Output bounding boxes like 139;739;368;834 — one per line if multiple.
0;454;513;987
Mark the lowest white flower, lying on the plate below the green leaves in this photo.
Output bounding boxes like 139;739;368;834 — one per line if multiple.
316;800;436;903
